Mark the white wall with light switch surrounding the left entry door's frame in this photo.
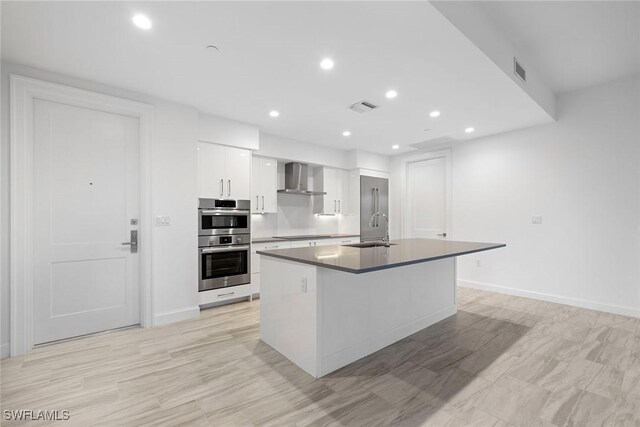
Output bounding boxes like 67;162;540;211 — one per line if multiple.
0;62;198;356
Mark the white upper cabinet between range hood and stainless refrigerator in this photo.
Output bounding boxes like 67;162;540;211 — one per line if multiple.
313;167;349;214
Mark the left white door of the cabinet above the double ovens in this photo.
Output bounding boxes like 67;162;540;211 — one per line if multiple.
198;142;225;199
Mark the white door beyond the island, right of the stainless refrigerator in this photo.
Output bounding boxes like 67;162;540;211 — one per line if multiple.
403;157;449;239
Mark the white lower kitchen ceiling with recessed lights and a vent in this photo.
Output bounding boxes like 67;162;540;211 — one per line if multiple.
2;1;552;154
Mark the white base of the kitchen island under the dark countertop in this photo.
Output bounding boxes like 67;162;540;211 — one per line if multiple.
260;254;456;378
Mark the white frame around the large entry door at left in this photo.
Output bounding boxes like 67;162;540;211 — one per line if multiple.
9;74;154;357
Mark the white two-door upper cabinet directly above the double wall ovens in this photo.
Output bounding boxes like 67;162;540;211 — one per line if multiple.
198;141;251;200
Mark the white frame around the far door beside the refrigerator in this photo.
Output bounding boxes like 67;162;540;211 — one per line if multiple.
400;149;453;239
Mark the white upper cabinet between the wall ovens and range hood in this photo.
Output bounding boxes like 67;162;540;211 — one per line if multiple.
251;157;278;213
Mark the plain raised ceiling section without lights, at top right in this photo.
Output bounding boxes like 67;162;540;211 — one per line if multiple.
465;1;640;92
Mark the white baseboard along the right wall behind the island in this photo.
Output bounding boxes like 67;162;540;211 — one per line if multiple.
458;280;640;317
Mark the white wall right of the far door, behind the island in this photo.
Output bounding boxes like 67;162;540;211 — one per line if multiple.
394;76;640;316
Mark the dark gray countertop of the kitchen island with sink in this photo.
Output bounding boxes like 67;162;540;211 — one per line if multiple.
258;239;506;274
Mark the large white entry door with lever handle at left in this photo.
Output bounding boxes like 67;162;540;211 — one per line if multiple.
33;99;141;344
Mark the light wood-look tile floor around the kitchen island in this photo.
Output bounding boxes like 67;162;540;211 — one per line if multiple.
0;289;640;426
